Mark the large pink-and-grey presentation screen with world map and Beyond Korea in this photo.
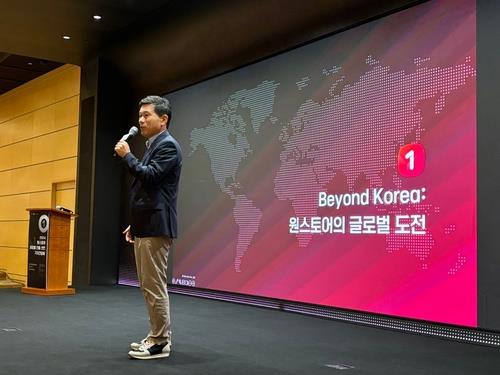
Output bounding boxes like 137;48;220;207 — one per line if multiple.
130;0;477;327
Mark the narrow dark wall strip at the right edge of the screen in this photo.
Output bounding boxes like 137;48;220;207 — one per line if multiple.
477;0;500;331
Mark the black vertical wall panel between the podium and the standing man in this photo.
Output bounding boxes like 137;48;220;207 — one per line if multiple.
90;61;134;284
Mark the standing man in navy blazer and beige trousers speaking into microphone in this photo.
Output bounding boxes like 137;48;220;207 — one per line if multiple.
115;96;182;359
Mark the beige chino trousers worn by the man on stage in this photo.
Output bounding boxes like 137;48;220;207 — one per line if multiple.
134;237;172;344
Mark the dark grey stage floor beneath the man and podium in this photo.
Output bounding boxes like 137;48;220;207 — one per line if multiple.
0;286;500;375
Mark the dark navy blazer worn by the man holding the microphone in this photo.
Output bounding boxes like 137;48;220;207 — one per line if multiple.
123;131;182;238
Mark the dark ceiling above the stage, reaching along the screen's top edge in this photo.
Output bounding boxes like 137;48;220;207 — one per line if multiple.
0;0;421;94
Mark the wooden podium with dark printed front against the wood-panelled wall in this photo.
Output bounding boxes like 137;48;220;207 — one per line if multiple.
21;208;75;296
